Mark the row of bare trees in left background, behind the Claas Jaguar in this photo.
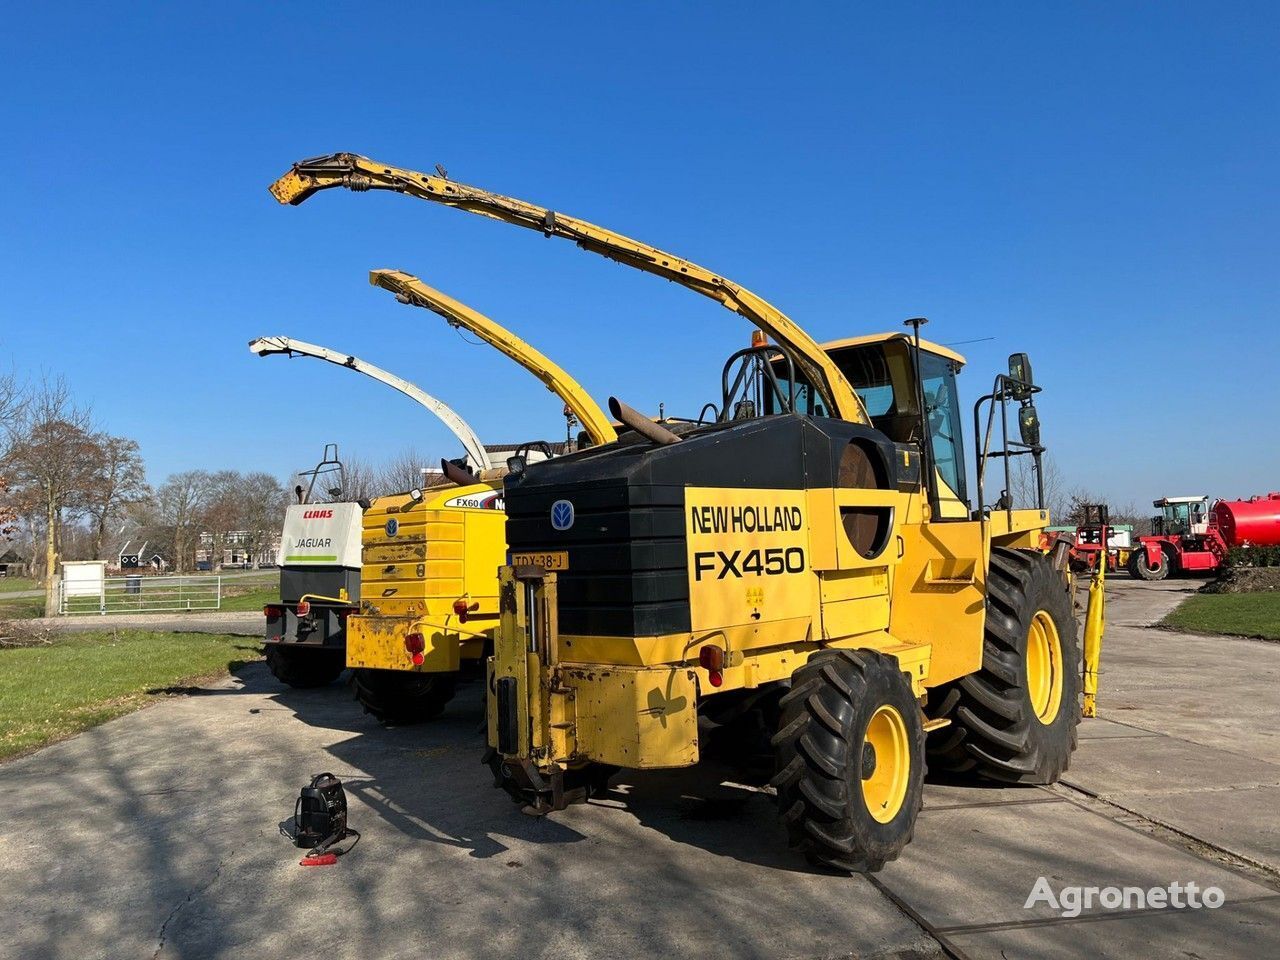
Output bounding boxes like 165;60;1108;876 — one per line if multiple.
0;374;453;609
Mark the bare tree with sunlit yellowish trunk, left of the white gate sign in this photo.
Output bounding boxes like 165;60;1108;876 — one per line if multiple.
5;378;99;611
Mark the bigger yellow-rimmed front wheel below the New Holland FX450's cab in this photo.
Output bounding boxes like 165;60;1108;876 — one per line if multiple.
928;547;1080;783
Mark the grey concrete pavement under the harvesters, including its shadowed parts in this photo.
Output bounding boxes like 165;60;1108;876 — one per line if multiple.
0;580;1280;960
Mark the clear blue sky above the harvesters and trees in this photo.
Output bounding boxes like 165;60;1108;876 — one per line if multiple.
0;3;1280;504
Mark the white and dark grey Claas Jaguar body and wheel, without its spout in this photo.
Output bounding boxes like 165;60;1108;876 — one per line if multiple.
262;443;362;687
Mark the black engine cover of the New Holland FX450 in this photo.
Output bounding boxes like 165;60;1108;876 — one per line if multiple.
506;413;918;636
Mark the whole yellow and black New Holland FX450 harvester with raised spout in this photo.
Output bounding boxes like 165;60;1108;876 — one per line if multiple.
271;154;1102;870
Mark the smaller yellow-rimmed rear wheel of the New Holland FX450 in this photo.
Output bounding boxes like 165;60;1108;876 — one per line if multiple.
772;650;924;873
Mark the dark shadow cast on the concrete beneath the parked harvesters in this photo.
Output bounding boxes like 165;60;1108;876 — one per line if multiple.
241;668;1029;876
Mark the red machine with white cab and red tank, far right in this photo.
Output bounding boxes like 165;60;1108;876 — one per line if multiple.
1129;493;1280;580
